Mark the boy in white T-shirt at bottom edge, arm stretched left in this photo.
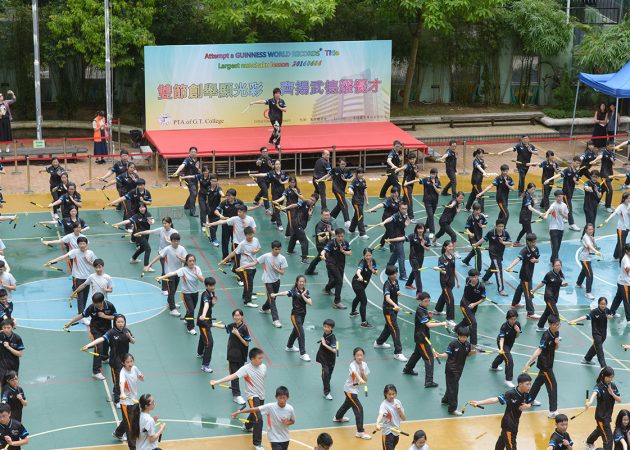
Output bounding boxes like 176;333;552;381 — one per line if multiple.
232;386;295;450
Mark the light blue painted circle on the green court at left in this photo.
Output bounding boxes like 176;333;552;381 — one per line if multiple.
12;277;166;331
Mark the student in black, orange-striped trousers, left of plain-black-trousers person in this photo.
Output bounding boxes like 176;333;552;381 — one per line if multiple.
403;292;446;388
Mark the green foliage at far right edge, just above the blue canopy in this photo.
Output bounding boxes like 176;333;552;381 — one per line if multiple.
575;19;630;73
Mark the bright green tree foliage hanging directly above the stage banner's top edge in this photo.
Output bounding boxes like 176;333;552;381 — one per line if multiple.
203;0;337;42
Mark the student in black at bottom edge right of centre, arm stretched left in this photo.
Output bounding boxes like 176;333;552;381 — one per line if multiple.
468;373;532;450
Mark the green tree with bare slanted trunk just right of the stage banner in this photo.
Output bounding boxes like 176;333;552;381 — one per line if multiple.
375;0;504;109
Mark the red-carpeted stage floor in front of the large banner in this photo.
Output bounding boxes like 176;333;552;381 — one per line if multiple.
145;122;427;160
